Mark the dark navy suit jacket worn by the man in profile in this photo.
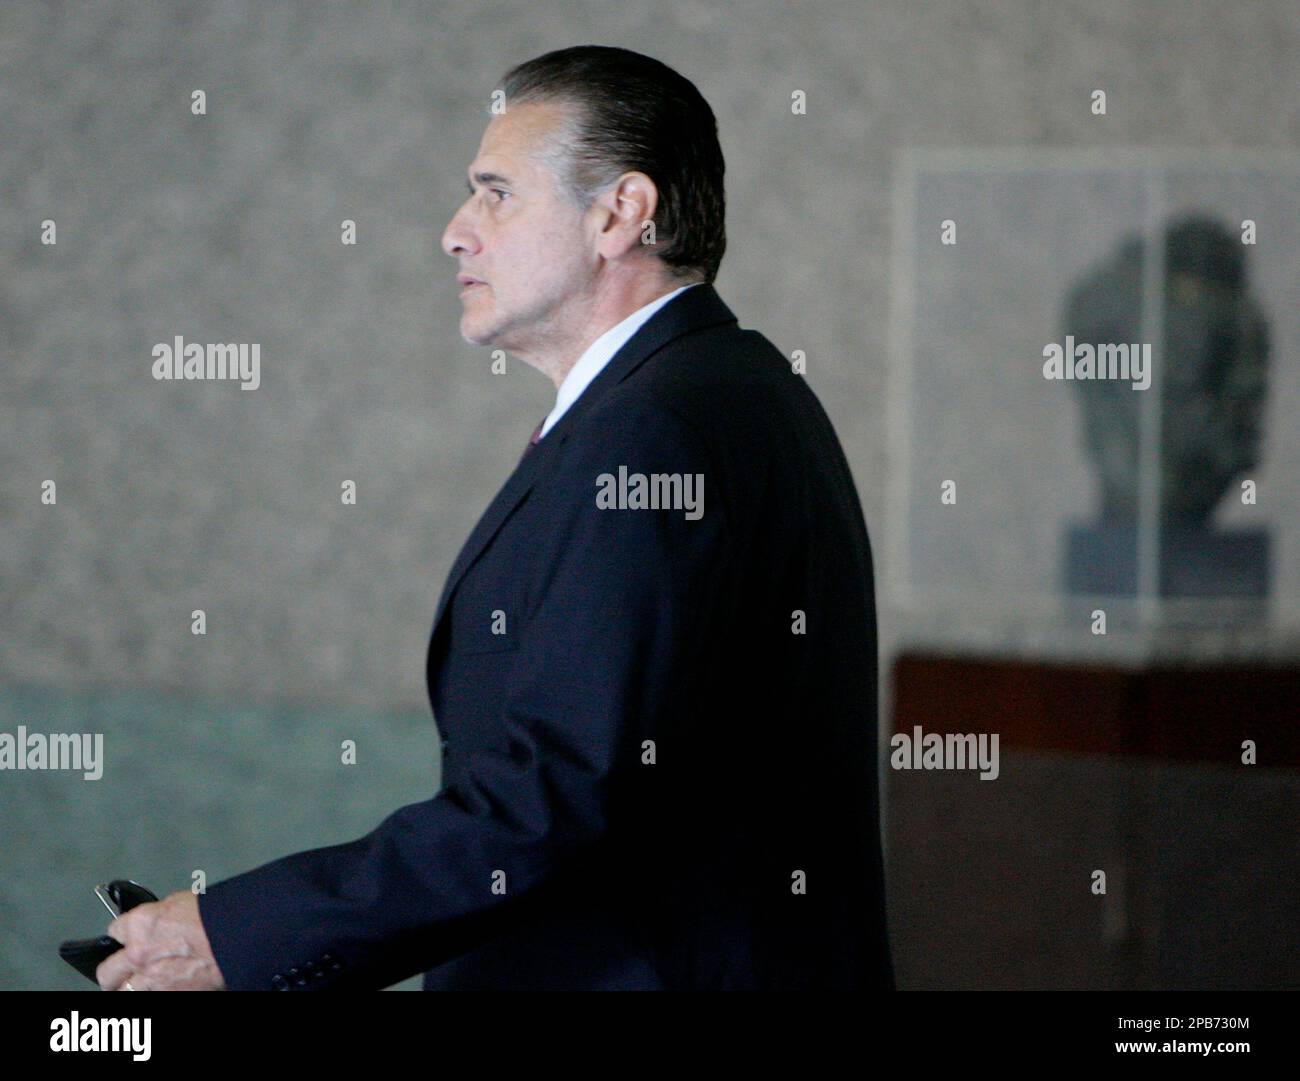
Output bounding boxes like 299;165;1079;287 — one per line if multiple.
199;285;893;990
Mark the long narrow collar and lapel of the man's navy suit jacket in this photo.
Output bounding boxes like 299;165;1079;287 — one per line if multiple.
430;283;736;641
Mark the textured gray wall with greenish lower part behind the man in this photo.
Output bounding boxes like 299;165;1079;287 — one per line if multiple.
0;0;1300;986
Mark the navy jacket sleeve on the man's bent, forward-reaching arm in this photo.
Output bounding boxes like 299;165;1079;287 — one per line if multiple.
199;391;727;990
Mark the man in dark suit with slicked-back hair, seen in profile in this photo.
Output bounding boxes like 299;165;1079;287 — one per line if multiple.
101;47;893;990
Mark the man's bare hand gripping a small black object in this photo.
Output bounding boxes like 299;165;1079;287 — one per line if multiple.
95;890;226;991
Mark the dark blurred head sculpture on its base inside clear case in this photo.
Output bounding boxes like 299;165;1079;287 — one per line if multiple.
1063;214;1269;596
